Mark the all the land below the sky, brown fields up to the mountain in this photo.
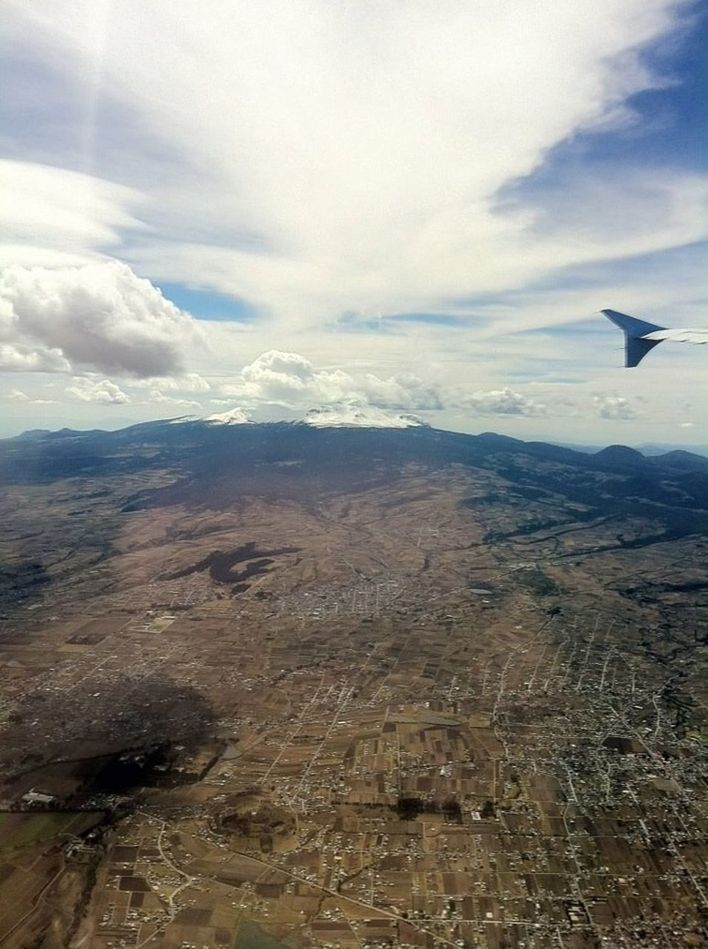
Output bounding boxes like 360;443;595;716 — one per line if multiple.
0;422;708;949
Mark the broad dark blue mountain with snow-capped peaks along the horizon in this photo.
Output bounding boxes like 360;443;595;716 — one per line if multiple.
0;413;708;530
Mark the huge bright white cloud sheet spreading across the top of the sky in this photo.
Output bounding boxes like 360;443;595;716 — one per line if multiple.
1;0;708;325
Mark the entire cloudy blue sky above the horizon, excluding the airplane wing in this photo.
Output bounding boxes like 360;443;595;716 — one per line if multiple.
0;0;708;446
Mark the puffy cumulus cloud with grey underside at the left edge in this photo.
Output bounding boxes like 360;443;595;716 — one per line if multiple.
0;261;201;376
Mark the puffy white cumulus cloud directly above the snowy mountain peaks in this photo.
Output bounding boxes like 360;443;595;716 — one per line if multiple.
222;349;443;410
